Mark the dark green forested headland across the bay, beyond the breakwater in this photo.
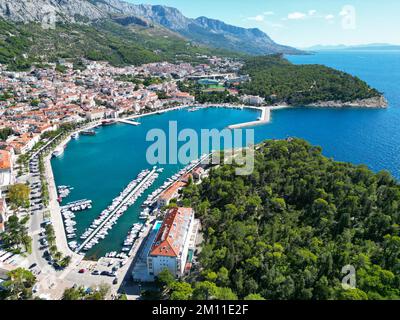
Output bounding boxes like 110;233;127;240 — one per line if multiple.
241;55;381;105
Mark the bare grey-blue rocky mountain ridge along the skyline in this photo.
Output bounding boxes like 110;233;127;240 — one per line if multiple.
0;0;301;55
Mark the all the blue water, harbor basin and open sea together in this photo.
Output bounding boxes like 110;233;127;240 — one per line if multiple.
52;52;400;256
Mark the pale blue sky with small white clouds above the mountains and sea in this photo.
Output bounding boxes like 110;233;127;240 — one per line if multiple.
126;0;400;47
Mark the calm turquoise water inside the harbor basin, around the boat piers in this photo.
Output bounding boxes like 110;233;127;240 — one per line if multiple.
52;108;260;257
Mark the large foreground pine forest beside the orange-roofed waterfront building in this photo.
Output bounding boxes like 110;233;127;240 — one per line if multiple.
182;139;400;299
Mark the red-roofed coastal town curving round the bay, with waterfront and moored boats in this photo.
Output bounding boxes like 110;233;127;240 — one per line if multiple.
0;57;271;299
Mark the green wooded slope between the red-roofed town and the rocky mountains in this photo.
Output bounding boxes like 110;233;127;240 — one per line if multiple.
0;19;239;70
